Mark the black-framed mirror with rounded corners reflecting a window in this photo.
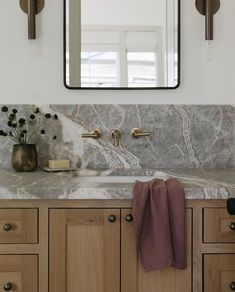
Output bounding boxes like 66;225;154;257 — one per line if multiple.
64;0;180;89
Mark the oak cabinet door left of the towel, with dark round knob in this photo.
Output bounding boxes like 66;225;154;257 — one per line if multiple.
49;209;120;292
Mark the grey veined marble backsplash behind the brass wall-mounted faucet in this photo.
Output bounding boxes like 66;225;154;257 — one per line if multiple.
0;105;235;169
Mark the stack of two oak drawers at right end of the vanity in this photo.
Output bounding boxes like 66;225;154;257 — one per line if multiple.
201;207;235;292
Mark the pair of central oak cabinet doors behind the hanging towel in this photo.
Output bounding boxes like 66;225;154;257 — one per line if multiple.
49;209;192;292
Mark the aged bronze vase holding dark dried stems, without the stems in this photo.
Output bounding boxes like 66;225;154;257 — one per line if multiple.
12;144;38;172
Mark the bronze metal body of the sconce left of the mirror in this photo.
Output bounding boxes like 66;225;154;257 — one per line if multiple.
20;0;45;40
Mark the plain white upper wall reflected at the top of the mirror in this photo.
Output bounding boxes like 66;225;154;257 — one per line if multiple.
81;0;166;26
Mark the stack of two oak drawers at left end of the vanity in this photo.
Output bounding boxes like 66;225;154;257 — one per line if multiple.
0;206;39;292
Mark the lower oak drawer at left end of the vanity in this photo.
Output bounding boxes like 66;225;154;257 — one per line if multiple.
0;255;38;292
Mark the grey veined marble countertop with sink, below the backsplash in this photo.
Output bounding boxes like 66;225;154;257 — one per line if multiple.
0;169;235;199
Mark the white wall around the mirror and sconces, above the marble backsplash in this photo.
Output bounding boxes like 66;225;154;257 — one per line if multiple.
0;0;235;104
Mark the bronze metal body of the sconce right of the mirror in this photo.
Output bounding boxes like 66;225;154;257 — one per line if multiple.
196;0;220;41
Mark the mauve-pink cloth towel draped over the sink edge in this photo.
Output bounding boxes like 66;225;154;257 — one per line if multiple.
132;179;186;272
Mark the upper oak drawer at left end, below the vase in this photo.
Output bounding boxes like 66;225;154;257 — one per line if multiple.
0;209;38;243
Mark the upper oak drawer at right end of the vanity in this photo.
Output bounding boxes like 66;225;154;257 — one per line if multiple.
203;208;235;242
